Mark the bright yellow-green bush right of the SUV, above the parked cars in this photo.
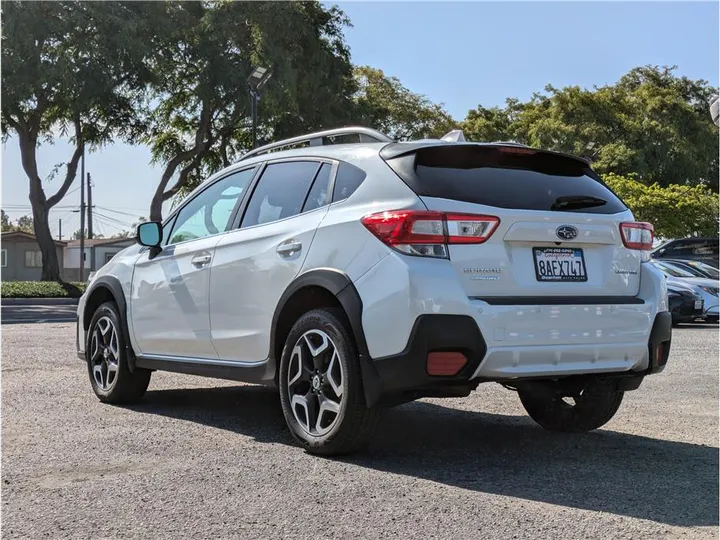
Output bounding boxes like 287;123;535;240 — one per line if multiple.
603;174;720;238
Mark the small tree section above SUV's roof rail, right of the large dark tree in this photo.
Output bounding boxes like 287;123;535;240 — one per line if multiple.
355;66;457;140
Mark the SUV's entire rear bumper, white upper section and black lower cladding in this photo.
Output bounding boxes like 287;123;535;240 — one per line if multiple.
354;255;672;397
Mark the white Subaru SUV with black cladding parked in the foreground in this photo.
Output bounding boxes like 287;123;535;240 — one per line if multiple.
77;128;672;454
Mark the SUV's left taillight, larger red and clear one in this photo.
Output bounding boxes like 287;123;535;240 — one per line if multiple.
360;210;500;258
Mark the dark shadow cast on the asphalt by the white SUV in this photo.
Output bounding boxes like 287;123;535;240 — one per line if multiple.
126;386;719;527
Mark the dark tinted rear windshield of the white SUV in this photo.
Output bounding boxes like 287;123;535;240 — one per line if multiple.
386;145;627;214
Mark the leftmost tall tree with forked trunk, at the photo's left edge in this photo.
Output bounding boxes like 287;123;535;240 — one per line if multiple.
2;0;162;280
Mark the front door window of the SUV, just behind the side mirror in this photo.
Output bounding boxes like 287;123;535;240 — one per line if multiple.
169;169;254;244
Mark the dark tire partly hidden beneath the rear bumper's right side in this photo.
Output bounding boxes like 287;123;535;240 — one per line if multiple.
518;383;625;433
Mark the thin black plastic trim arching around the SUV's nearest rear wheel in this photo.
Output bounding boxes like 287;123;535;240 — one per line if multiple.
270;268;382;407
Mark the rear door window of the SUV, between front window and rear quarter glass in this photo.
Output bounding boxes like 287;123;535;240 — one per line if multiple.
242;161;320;227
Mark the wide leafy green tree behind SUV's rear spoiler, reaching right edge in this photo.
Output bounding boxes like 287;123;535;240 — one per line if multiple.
463;66;720;191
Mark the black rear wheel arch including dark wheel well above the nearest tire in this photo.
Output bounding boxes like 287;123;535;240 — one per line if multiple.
270;268;381;407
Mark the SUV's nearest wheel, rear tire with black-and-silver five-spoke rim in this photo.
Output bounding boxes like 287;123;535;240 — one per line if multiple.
279;309;380;456
